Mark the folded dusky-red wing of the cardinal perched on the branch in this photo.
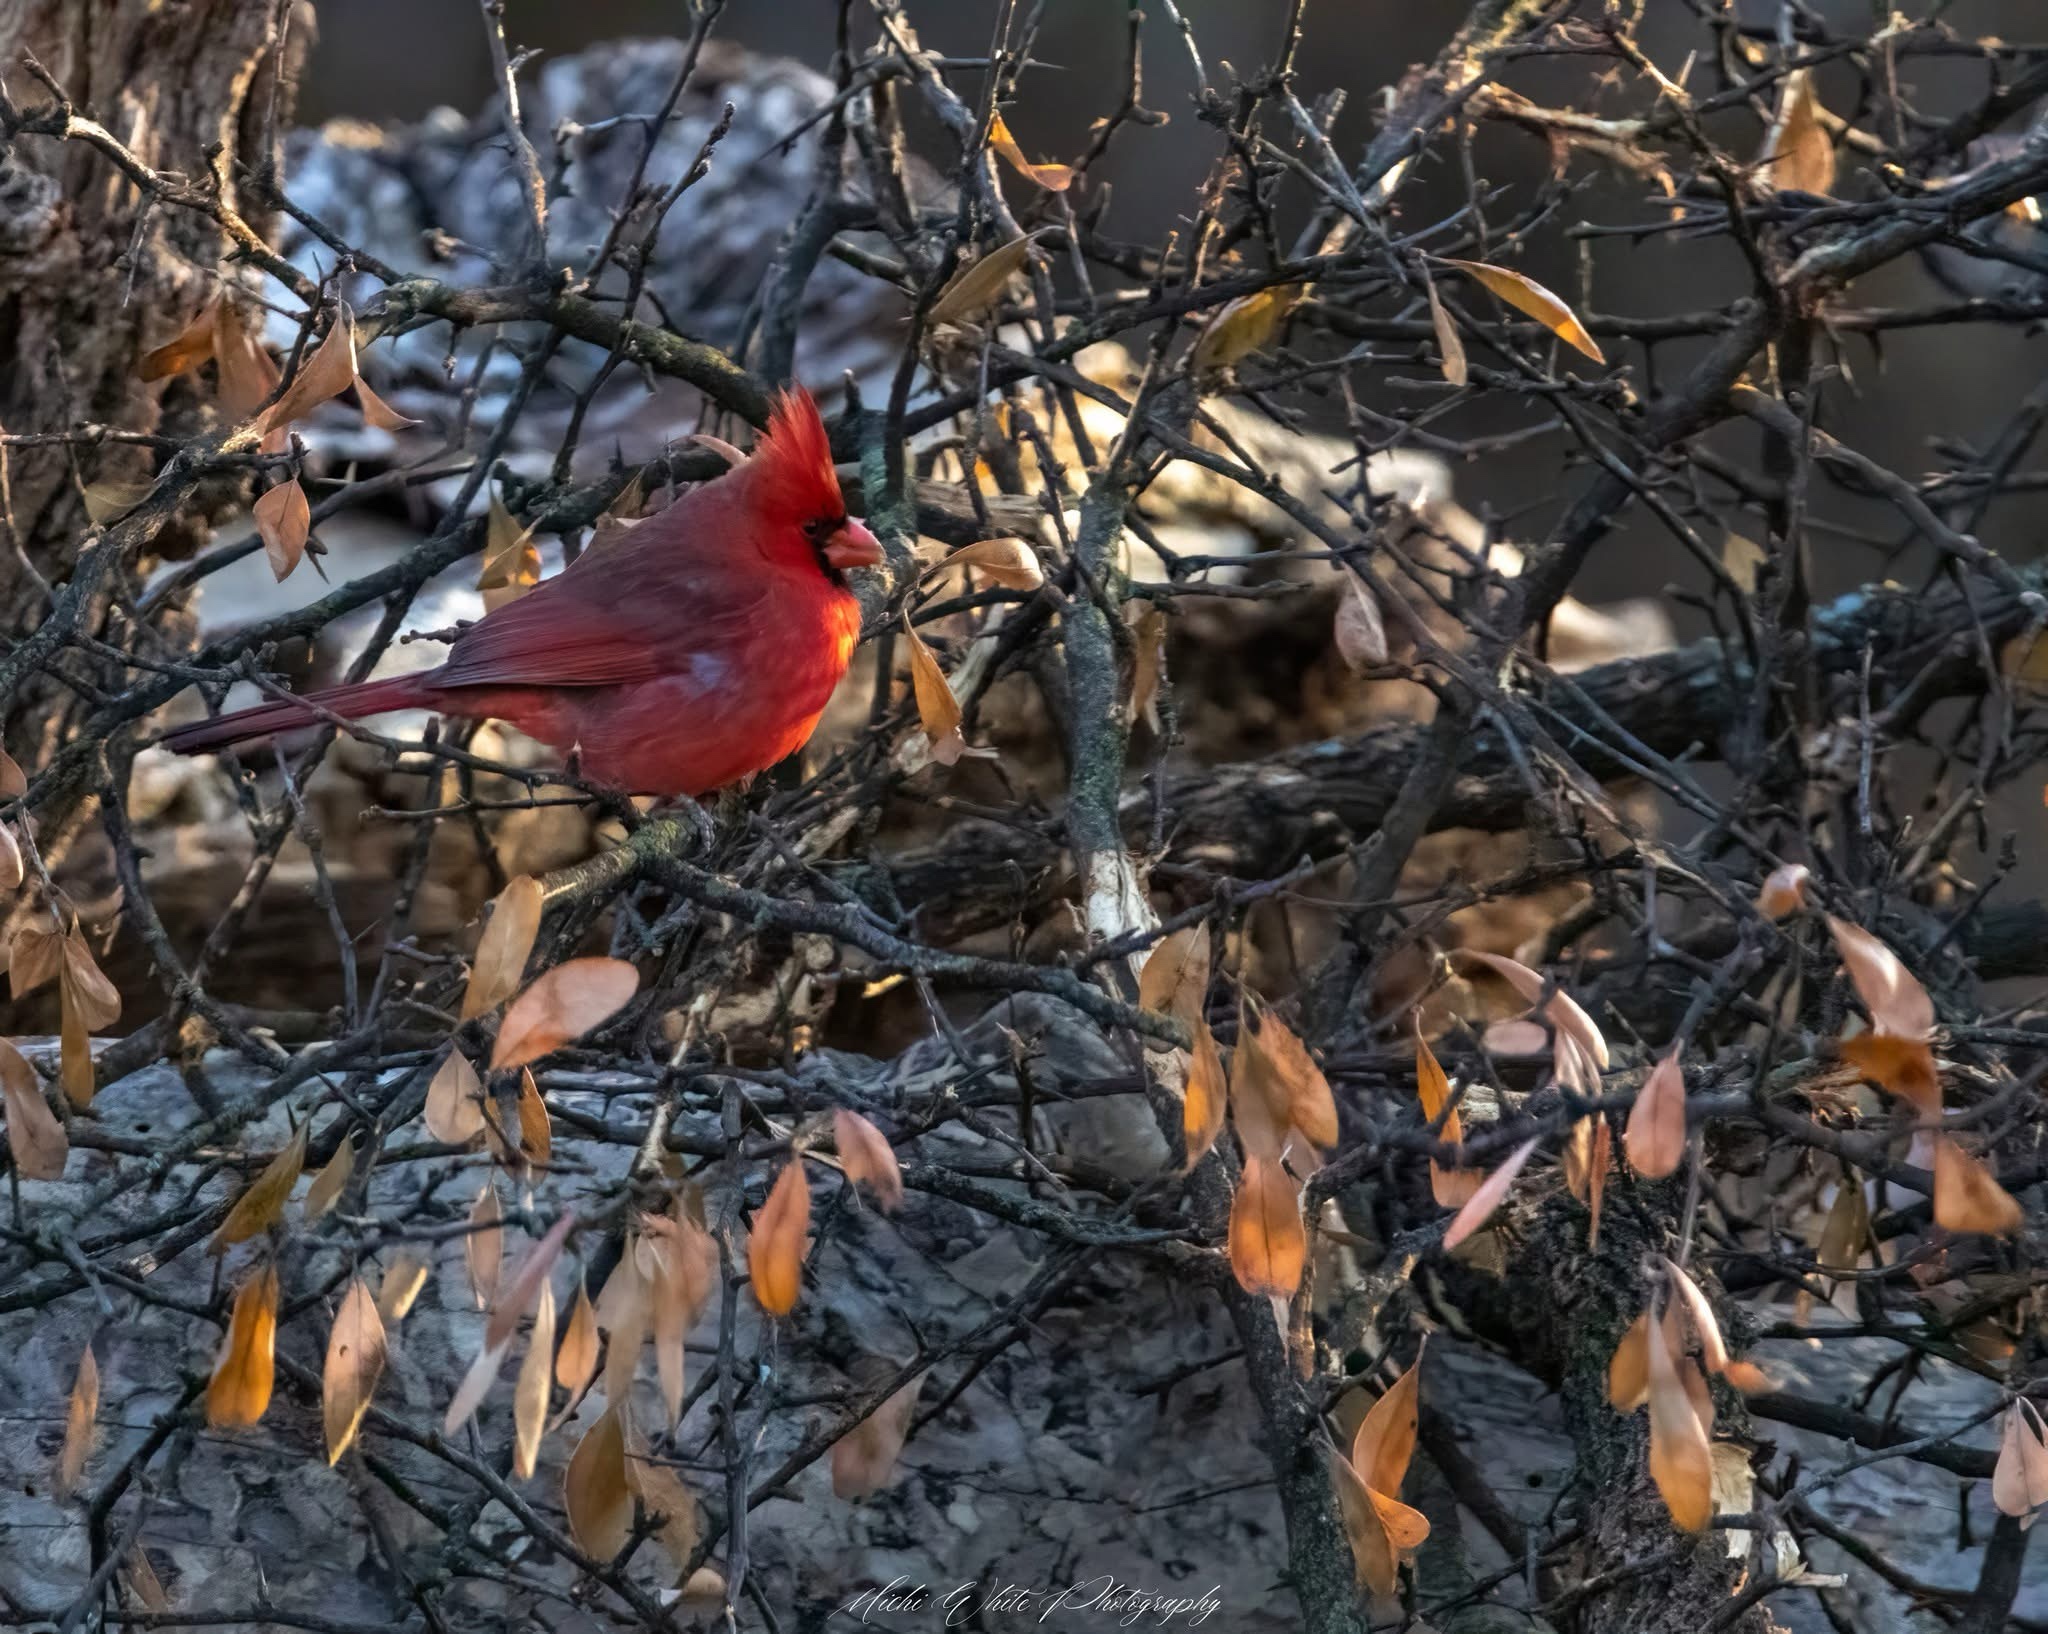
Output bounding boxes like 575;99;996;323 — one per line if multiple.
434;518;772;686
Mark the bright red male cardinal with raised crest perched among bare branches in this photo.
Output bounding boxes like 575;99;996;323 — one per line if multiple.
164;389;883;794
